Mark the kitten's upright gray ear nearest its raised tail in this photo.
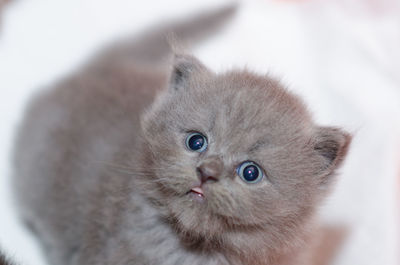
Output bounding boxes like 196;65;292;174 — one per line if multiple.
170;54;209;90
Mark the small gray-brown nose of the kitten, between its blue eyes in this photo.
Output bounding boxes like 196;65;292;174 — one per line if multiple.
197;156;223;183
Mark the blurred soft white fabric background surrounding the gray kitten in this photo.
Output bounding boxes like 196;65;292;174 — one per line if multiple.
0;0;400;265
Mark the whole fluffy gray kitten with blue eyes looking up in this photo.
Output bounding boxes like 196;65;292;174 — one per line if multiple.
14;4;351;265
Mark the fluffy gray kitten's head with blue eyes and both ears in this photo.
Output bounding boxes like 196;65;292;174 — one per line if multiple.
142;55;350;248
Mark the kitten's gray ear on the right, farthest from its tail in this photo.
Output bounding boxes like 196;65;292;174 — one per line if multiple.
314;127;351;176
